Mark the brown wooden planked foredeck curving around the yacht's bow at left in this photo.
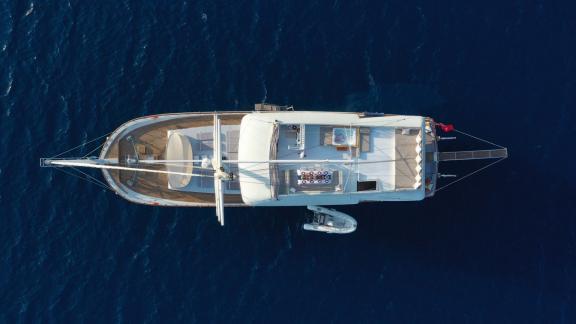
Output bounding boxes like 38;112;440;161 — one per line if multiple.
100;112;246;206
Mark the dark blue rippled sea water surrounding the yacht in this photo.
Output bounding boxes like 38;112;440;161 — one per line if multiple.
0;0;576;323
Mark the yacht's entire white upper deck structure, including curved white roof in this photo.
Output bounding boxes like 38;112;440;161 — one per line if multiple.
238;112;425;206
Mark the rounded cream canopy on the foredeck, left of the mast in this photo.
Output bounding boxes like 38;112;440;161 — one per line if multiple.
166;132;193;189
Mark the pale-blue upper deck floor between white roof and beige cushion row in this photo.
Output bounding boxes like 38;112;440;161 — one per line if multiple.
278;125;394;194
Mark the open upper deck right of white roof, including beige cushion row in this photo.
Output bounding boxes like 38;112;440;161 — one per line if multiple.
277;125;421;194
